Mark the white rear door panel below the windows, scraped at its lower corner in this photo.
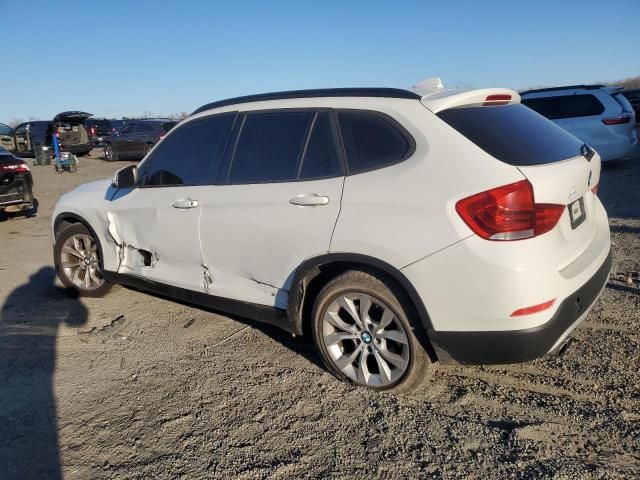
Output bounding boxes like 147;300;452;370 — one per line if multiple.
200;177;344;308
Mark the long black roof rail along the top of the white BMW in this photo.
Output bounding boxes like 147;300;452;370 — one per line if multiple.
192;88;422;115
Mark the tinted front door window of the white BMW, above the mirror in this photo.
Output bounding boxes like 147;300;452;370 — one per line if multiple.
145;113;236;186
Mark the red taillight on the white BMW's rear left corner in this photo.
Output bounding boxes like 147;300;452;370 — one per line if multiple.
456;180;565;241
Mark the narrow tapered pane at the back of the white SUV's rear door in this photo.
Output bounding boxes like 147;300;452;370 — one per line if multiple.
299;112;342;180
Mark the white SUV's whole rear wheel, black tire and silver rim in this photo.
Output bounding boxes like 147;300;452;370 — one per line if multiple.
311;270;432;393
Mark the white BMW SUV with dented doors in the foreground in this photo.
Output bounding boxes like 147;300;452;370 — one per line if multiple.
52;88;611;391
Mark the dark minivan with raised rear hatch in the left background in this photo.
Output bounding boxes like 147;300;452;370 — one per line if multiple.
13;111;93;157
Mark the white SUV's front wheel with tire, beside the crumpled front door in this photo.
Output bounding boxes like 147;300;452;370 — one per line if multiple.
53;223;112;297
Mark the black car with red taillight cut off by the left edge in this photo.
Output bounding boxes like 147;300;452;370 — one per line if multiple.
0;147;35;214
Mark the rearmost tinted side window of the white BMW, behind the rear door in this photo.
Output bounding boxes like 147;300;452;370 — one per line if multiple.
338;111;412;173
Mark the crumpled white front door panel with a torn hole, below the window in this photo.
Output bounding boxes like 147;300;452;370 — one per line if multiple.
108;186;211;291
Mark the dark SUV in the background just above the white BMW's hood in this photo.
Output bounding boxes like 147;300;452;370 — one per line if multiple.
104;120;178;162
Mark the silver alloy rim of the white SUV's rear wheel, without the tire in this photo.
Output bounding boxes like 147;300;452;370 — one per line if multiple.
322;293;410;387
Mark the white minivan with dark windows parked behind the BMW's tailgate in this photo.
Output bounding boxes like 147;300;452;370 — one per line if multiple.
521;85;638;161
